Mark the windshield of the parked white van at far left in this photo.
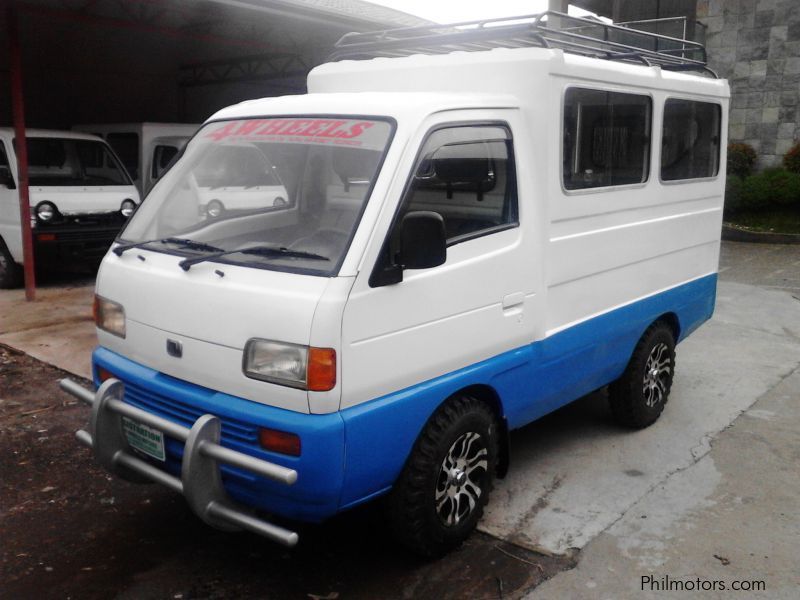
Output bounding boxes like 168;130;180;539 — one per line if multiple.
26;137;131;186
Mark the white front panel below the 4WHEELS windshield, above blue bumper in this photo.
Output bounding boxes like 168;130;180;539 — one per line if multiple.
96;249;330;412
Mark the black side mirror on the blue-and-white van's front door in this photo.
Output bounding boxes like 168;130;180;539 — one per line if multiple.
398;210;447;269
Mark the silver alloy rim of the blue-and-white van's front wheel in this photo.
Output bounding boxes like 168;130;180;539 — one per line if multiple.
435;431;489;527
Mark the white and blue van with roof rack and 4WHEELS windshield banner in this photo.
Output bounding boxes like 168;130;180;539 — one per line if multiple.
62;13;729;556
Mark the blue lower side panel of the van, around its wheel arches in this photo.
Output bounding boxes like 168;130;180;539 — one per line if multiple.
334;274;717;507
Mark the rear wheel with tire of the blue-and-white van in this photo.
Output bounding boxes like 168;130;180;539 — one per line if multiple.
608;321;675;429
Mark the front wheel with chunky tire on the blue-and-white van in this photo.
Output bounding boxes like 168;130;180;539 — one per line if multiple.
387;396;498;558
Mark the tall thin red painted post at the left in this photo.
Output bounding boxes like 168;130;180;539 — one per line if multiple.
6;1;36;301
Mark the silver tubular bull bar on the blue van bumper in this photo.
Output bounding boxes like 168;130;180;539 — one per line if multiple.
60;378;299;547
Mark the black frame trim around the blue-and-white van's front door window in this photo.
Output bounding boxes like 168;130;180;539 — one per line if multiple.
368;119;521;288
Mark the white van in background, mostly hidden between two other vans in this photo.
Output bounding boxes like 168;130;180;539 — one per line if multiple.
72;123;200;198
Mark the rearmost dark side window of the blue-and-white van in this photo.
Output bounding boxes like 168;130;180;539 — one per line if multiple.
661;98;722;181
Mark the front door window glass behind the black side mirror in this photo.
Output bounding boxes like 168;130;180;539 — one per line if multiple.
398;125;518;245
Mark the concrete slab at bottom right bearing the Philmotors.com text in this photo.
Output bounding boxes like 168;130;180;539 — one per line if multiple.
527;369;800;600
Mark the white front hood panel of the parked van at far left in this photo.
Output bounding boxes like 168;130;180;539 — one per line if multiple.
30;185;139;215
